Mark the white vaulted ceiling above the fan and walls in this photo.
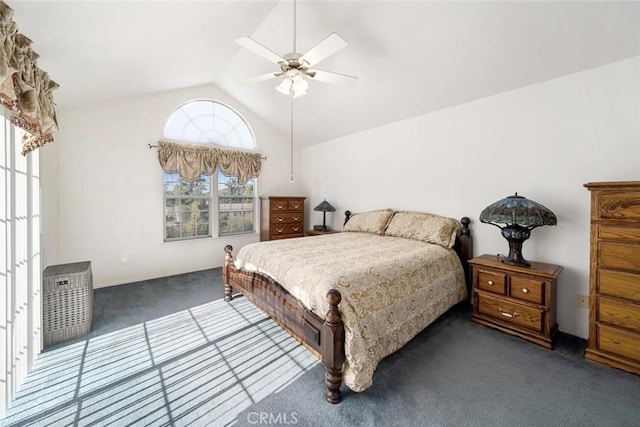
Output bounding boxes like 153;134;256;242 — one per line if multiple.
7;0;640;145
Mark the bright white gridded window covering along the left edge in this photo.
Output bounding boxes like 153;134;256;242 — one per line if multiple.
0;109;42;418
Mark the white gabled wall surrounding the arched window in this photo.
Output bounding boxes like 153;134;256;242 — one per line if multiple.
42;86;302;287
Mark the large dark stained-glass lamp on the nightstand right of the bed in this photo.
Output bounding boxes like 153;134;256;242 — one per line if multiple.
480;193;558;267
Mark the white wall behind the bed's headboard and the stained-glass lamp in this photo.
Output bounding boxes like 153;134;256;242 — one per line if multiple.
302;57;640;338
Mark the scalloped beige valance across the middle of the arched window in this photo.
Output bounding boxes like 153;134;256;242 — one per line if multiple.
158;141;262;184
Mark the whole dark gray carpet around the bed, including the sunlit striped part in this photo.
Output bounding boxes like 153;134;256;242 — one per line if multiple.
2;269;640;427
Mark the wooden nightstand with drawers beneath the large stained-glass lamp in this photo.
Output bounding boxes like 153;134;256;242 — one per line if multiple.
469;255;562;349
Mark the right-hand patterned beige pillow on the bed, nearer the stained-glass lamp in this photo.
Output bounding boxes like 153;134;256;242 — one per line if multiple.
384;212;460;248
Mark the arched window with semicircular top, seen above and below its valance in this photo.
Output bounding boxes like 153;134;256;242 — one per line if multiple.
162;99;256;241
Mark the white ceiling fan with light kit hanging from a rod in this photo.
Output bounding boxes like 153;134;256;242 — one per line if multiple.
236;0;358;98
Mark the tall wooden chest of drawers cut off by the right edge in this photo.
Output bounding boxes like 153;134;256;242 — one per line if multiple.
584;181;640;374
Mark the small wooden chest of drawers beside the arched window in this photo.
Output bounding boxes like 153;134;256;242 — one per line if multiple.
260;196;305;241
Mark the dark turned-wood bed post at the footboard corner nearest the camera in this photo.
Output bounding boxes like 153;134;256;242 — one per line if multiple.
320;289;345;404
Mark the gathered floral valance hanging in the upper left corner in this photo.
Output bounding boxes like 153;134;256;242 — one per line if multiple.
0;0;58;155
